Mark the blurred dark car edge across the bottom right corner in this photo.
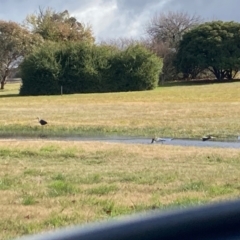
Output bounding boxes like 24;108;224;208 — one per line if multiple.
19;200;240;240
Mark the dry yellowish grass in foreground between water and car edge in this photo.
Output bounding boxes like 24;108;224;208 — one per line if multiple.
0;140;240;239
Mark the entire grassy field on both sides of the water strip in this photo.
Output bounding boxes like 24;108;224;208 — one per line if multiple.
0;82;240;239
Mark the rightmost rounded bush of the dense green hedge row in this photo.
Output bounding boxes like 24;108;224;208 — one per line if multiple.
109;44;162;91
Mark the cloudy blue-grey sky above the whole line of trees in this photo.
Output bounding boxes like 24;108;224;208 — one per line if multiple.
0;0;240;41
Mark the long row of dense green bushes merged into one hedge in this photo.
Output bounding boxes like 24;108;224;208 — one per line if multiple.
20;41;162;95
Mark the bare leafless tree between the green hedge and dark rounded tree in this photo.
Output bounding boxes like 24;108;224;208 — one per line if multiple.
145;11;202;82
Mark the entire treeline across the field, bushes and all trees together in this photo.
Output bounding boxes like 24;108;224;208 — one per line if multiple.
0;9;240;95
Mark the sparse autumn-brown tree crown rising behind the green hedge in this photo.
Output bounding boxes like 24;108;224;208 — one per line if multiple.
25;8;94;42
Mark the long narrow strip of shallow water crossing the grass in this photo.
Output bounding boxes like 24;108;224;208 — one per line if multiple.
0;136;240;148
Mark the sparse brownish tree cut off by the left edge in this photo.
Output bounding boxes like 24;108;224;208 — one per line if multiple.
0;20;42;89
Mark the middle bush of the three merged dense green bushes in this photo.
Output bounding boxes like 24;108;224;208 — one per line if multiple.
57;42;115;93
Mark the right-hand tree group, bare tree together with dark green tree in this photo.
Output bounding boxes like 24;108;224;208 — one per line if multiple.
147;12;240;82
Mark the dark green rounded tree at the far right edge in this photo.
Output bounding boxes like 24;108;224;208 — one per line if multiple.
175;21;240;80
